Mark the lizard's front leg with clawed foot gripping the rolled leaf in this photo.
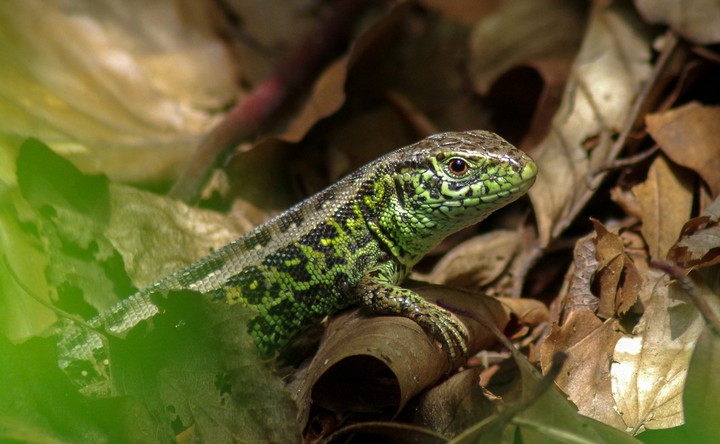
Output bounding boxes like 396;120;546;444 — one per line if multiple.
355;261;468;362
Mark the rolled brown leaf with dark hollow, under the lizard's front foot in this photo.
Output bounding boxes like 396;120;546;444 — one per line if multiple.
296;287;532;424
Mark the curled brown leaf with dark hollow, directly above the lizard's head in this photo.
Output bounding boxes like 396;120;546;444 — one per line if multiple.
466;1;585;146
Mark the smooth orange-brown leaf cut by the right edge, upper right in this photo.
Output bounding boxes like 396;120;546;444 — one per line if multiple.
645;103;720;197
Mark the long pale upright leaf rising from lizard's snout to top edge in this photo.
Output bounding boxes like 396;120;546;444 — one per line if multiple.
529;3;650;245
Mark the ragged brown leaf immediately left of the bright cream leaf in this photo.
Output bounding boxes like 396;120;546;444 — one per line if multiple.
540;310;624;428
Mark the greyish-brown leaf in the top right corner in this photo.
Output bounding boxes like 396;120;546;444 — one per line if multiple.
635;0;720;44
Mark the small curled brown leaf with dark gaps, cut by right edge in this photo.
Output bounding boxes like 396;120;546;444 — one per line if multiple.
667;194;720;268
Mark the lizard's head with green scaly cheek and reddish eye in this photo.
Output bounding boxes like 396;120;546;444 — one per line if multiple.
386;131;537;253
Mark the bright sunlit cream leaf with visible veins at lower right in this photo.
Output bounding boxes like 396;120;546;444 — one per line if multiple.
610;270;704;434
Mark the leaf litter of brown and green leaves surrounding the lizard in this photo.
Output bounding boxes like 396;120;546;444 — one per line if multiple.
0;0;720;442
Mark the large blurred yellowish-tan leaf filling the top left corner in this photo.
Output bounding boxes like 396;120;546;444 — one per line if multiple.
0;0;239;180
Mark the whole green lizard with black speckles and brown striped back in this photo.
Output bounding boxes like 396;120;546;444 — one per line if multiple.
58;131;537;393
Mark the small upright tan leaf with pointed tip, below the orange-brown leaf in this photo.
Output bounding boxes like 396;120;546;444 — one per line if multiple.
633;156;693;260
